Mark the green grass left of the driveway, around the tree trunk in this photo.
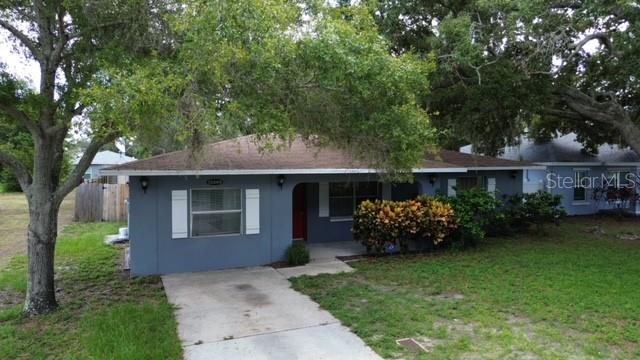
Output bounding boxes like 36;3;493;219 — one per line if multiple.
0;223;182;359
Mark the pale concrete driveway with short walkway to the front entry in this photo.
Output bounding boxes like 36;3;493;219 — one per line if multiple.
162;266;380;360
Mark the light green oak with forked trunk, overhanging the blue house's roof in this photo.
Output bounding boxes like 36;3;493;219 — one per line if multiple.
0;0;433;314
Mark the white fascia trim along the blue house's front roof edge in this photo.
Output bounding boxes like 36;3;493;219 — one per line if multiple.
100;167;470;176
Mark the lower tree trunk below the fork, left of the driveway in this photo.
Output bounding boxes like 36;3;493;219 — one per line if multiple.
24;191;59;315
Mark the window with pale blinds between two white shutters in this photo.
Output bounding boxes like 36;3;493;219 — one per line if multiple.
191;189;242;236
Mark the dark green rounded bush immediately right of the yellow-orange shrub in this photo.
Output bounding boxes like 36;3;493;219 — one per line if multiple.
430;189;504;246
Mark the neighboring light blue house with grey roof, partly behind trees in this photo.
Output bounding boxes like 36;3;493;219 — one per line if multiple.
460;133;640;215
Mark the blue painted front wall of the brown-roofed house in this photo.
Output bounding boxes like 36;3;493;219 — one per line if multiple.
129;171;522;276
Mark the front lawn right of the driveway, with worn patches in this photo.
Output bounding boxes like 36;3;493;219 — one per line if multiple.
293;218;640;359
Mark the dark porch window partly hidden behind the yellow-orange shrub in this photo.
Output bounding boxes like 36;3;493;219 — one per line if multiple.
329;181;382;218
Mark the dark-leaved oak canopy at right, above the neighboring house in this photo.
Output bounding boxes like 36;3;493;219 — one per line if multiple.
377;0;640;154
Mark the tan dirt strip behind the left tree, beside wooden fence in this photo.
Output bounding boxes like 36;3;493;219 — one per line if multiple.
0;192;75;269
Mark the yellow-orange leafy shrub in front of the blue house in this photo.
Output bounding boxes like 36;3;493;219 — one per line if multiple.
352;199;456;253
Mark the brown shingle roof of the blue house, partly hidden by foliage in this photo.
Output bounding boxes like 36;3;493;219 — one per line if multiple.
106;136;529;173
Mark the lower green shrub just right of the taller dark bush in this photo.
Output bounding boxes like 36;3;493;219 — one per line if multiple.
504;191;567;231
